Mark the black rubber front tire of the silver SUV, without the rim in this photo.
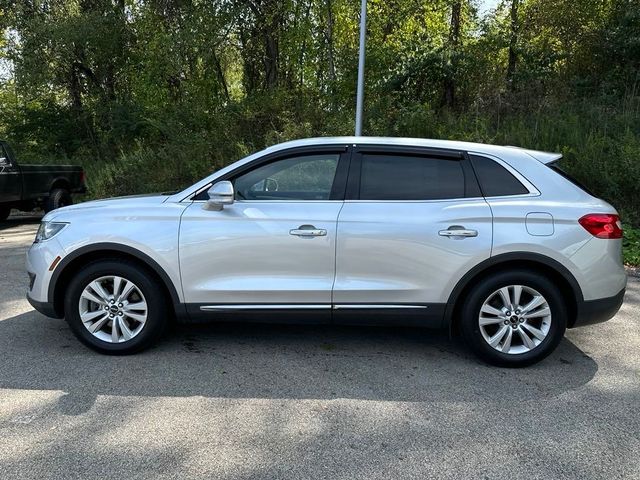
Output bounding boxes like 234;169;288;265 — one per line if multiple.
64;259;171;355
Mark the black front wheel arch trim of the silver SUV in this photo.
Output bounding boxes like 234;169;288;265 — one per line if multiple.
47;243;184;317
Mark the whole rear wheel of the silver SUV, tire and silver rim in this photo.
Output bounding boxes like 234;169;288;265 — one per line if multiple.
460;271;567;367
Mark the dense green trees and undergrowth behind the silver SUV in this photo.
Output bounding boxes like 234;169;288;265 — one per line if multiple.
0;0;640;229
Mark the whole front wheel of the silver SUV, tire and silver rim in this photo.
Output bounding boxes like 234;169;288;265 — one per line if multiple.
65;260;169;354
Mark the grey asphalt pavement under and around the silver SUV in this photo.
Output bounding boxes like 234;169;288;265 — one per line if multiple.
0;217;640;480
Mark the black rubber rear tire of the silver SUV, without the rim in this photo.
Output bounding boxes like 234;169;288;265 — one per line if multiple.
460;270;567;367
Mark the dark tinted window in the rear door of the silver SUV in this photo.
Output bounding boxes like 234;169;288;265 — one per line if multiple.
360;154;465;200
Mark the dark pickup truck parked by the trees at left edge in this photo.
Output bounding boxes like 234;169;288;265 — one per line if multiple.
0;141;87;221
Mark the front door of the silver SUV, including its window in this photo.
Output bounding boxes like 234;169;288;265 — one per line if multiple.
180;148;346;314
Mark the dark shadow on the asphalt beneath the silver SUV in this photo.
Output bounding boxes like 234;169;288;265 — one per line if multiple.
0;311;598;415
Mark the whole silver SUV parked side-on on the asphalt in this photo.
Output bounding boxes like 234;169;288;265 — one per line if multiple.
27;137;626;366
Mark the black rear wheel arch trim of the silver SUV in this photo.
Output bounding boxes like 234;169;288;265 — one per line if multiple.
444;252;584;335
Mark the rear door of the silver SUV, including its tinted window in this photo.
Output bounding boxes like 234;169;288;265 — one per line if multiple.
333;145;492;323
